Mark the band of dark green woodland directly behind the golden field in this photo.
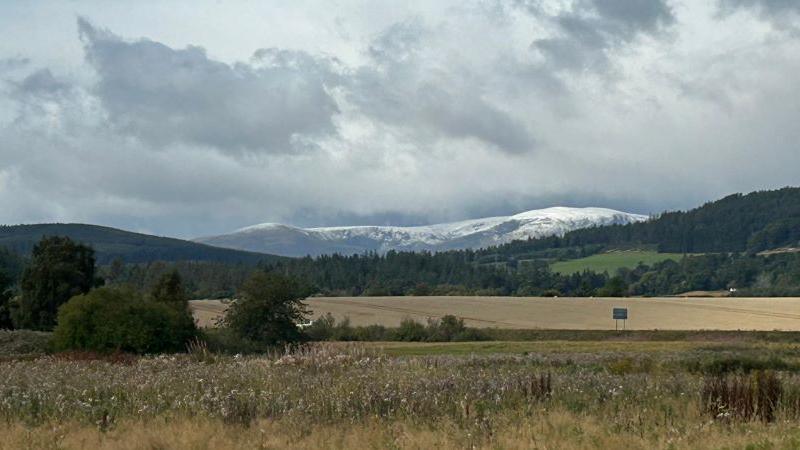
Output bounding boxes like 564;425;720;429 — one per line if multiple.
86;246;800;298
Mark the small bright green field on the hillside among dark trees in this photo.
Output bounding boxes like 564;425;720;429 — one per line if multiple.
550;250;683;275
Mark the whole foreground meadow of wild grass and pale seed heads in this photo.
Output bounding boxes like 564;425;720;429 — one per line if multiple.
0;342;800;449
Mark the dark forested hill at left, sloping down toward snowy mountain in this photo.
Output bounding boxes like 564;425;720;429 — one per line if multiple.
0;224;282;264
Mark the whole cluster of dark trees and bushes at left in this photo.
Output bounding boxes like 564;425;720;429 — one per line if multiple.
0;236;308;353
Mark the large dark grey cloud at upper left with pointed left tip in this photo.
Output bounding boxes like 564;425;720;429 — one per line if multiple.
78;19;338;153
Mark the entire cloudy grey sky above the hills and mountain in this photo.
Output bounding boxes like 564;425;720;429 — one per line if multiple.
0;0;800;238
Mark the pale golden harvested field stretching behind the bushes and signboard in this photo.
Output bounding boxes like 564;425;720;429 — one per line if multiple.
192;297;800;331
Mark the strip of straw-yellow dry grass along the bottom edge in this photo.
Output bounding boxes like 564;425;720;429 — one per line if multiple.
0;410;800;450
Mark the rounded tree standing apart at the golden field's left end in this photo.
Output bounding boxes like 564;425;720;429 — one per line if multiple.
224;271;308;345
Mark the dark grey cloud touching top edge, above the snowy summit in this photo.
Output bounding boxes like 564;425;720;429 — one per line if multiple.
524;0;675;71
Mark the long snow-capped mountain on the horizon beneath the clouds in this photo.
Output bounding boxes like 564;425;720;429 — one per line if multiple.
195;207;647;256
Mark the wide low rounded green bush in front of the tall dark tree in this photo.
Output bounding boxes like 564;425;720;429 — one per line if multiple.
53;288;196;353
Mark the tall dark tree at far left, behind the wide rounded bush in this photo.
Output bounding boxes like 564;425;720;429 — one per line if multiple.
14;236;96;330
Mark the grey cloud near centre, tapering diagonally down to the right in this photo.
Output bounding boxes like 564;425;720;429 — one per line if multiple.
349;21;536;154
